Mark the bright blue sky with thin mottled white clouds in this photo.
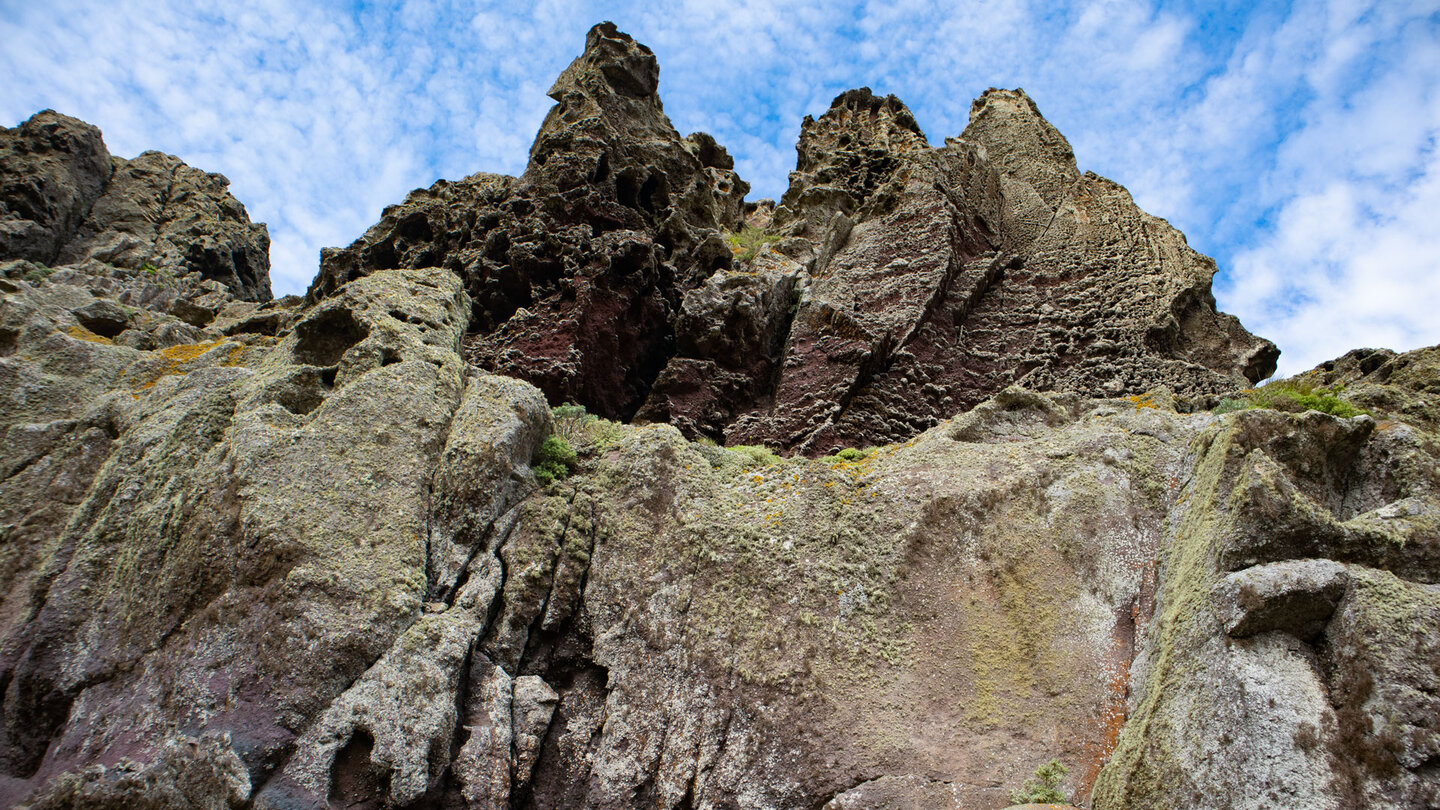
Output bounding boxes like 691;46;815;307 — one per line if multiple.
0;0;1440;375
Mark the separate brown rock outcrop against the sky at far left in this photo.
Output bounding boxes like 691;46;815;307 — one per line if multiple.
0;110;271;302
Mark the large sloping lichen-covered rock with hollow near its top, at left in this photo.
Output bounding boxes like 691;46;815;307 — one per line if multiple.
0;263;544;801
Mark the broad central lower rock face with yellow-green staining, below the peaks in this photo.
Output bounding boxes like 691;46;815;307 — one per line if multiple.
469;393;1192;807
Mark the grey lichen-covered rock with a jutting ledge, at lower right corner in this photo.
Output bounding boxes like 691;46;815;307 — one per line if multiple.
1094;397;1440;809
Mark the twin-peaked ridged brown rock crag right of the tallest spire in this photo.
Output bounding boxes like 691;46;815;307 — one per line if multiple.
724;89;1279;453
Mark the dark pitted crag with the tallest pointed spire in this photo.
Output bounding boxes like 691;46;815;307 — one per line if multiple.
310;23;749;419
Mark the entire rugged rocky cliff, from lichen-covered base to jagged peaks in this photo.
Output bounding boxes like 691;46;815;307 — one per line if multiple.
0;17;1440;810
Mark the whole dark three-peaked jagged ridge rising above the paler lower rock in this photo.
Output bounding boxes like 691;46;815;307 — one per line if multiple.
310;23;1279;455
